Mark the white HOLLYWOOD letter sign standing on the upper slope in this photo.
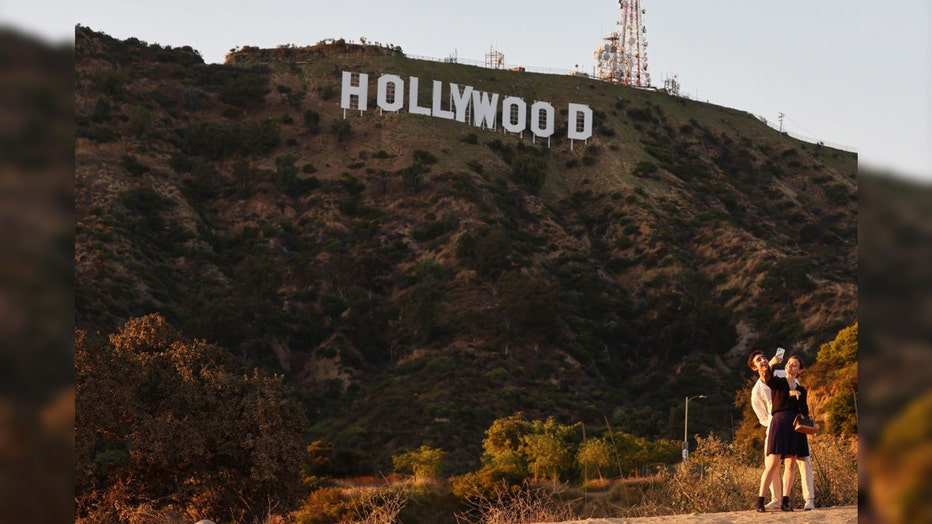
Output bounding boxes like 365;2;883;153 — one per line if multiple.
340;71;592;140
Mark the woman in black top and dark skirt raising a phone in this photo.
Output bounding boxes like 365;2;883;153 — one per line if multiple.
748;351;808;512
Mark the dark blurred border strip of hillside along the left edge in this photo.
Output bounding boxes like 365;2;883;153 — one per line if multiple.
0;22;75;522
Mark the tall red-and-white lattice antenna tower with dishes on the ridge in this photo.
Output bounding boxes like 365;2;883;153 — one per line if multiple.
593;0;650;87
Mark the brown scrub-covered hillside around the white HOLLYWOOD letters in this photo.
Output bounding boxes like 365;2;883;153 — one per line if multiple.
75;26;857;472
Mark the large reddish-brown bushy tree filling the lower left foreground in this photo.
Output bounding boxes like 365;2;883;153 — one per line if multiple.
75;314;307;521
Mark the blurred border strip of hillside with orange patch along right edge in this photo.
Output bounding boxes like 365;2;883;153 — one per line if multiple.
857;169;932;522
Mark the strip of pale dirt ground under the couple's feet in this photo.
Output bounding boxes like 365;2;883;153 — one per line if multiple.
546;506;858;524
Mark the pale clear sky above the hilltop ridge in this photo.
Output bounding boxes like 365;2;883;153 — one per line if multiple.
7;0;932;183
